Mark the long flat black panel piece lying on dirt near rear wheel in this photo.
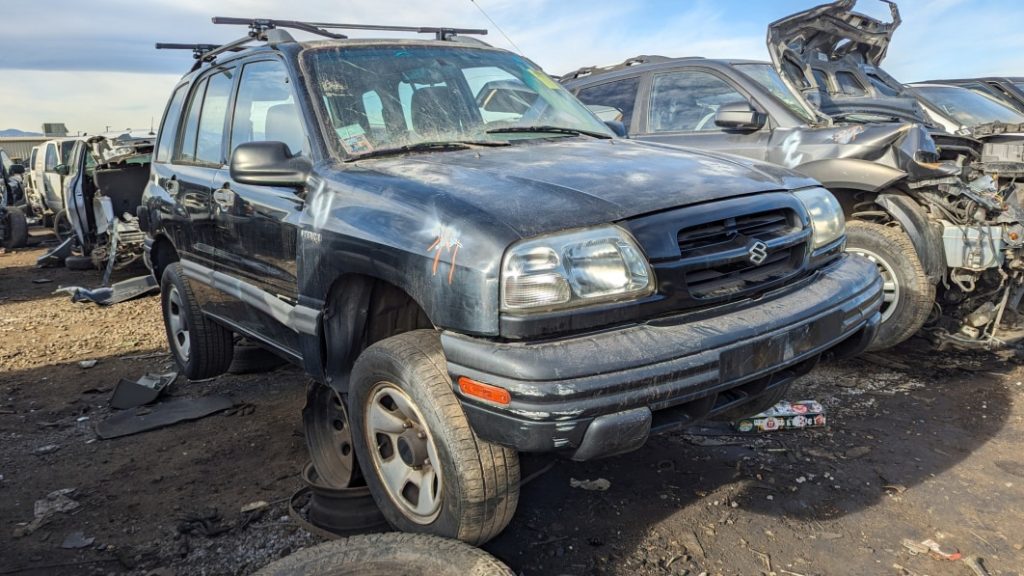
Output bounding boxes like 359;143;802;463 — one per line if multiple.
96;396;234;440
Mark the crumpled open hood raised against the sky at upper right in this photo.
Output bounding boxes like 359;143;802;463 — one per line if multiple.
768;0;929;124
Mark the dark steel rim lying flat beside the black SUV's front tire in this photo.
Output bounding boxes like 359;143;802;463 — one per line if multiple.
292;462;390;537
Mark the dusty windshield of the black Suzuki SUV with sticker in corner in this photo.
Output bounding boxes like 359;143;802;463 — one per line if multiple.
306;46;611;158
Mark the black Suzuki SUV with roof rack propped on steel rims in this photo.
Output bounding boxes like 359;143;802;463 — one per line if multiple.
139;18;882;542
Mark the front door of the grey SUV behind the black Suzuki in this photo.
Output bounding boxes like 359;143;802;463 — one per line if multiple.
634;68;771;160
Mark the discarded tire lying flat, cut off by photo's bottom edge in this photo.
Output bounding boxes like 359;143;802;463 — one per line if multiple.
256;532;515;576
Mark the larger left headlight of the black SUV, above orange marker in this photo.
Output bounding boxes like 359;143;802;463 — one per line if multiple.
502;225;654;312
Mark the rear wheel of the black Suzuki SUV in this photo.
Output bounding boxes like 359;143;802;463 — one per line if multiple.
160;262;234;380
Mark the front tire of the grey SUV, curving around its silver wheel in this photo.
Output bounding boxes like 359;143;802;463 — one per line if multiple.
846;220;935;351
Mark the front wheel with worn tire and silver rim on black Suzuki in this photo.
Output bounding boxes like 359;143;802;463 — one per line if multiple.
348;330;519;544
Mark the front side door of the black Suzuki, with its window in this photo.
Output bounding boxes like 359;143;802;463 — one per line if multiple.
213;57;309;351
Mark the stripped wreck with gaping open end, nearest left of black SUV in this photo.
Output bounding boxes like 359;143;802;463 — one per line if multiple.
63;132;155;286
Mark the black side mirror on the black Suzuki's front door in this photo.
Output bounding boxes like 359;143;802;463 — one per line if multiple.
229;141;312;188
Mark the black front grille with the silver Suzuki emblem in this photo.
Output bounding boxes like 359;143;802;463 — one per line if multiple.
677;208;808;299
